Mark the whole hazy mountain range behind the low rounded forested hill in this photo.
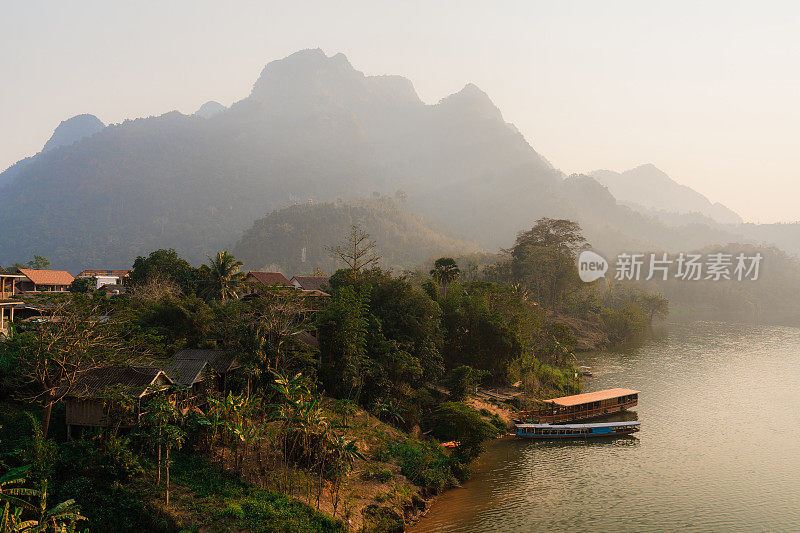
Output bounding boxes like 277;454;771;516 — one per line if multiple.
0;50;800;270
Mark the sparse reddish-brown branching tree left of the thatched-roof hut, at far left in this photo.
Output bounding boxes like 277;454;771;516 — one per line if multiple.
5;296;130;437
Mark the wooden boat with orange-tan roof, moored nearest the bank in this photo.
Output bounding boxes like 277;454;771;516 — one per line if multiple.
519;389;639;424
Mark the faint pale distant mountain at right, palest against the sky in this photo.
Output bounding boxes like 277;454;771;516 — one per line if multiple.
589;164;742;224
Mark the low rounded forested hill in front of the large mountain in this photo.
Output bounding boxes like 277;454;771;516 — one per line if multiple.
233;197;478;274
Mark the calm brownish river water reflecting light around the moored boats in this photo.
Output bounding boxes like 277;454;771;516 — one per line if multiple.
412;322;800;533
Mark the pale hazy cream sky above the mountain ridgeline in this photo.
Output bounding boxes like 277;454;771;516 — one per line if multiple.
0;0;800;222
